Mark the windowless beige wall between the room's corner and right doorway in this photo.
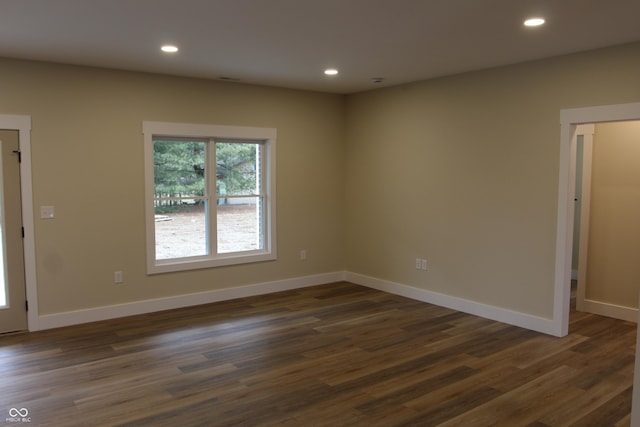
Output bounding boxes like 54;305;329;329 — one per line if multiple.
346;44;640;318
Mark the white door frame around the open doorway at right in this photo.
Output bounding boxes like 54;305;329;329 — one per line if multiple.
552;102;640;337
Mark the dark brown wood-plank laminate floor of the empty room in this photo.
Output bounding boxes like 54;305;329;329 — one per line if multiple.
0;283;635;427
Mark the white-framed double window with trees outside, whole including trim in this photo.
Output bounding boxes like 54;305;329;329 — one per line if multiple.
143;122;276;274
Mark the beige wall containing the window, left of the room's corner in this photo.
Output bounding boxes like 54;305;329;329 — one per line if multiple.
0;60;345;315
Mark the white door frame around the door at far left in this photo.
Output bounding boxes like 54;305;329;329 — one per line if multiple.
0;114;39;331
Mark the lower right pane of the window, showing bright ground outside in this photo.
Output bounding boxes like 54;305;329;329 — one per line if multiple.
218;197;264;253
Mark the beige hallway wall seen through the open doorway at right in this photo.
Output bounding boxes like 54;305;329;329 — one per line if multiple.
585;121;640;308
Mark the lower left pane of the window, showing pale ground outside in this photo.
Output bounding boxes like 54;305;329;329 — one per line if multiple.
155;202;208;260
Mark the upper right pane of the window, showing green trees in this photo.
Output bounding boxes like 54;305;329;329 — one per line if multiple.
216;142;260;196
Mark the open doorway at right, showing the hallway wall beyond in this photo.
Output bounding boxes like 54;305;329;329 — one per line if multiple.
572;121;640;322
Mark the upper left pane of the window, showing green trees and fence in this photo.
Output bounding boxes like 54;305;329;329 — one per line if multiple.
153;140;206;200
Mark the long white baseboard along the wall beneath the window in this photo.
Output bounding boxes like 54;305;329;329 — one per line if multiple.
29;271;345;331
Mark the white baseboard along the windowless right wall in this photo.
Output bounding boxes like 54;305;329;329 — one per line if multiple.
345;272;557;336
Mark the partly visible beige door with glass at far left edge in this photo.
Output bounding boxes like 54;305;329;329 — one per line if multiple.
0;130;27;333
